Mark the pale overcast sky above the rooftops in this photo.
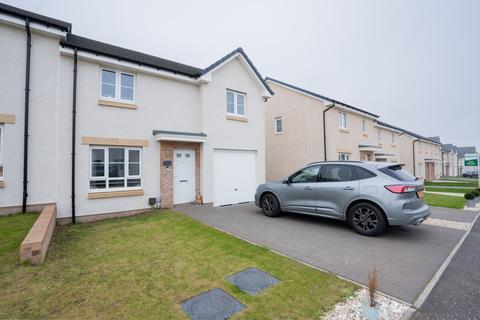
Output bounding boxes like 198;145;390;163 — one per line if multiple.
5;0;480;149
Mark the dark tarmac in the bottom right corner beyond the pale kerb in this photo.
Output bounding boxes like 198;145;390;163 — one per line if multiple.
413;214;480;320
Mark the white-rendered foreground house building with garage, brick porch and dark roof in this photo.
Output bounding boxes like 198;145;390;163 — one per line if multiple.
0;4;273;220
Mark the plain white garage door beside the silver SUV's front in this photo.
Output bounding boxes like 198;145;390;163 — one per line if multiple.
213;150;257;206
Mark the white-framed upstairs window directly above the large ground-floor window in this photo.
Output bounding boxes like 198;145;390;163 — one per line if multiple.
101;69;135;102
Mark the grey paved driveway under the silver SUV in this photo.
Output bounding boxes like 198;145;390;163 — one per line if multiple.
176;204;475;303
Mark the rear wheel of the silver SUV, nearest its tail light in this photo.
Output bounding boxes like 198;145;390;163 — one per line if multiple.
348;202;387;237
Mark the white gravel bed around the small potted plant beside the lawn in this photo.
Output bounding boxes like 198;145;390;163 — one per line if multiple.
322;288;409;320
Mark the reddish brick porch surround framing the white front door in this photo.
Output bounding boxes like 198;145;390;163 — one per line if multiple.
160;141;200;208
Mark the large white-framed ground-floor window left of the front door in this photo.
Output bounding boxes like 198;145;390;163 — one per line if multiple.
90;146;142;191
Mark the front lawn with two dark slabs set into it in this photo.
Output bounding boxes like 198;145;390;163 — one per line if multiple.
0;211;358;319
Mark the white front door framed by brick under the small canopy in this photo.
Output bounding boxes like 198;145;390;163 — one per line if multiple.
173;149;195;204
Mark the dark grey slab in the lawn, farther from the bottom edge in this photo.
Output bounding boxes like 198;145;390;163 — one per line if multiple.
227;268;280;296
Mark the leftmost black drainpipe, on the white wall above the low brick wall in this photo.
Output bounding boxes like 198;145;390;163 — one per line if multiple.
22;18;32;212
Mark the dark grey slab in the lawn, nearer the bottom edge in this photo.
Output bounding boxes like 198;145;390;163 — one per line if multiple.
181;288;245;320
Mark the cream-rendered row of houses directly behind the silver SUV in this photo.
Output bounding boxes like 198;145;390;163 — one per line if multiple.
265;78;441;180
